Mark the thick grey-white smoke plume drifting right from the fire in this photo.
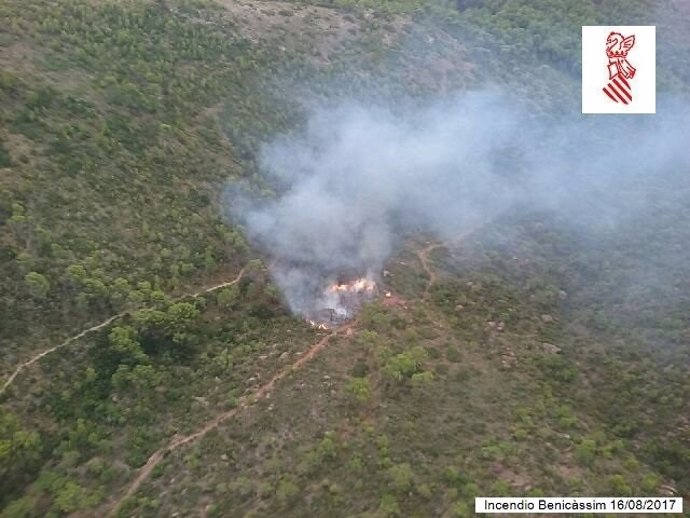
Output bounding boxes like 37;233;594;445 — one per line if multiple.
226;92;690;317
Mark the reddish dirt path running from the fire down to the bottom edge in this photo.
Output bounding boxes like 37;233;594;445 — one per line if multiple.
107;320;357;516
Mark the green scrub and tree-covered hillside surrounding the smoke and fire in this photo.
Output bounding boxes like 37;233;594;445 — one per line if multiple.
0;0;690;518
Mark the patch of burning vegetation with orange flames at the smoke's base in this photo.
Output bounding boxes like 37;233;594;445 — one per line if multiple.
306;277;377;329
